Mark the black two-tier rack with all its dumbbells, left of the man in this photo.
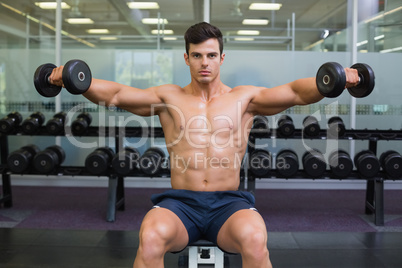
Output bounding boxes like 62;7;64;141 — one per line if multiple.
0;112;170;221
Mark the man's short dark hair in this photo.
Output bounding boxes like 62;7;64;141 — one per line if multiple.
184;22;223;55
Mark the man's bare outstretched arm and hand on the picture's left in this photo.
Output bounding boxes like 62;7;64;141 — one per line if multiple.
49;66;163;116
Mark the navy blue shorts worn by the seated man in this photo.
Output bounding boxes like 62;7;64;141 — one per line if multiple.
151;190;256;244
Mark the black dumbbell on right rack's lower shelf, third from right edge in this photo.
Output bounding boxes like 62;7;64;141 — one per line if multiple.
328;150;353;179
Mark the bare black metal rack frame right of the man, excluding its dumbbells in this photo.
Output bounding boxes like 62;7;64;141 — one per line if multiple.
247;129;402;226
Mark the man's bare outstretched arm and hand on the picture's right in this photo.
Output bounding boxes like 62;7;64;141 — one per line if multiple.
248;68;359;115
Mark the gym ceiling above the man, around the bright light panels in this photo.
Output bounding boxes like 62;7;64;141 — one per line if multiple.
0;0;358;50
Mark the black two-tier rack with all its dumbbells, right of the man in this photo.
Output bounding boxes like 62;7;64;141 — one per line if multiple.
246;115;402;226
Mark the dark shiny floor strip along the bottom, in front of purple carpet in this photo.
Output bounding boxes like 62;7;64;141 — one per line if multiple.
0;228;402;268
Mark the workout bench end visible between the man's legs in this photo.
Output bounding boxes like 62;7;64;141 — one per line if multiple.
188;240;224;268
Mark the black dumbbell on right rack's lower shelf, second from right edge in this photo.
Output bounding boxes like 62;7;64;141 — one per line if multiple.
353;150;380;178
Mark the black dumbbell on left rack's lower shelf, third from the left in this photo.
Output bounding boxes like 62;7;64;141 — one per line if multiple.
85;147;114;175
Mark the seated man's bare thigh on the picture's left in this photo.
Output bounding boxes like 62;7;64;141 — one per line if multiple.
140;207;188;252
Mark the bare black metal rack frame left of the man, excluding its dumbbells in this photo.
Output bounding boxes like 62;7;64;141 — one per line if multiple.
0;126;170;222
